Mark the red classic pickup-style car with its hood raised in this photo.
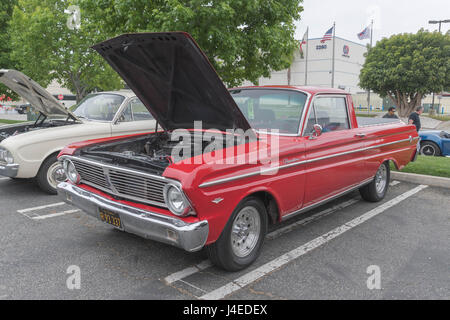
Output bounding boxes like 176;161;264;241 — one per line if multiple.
58;32;418;270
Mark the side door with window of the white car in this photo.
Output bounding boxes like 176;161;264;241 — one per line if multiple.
111;97;156;136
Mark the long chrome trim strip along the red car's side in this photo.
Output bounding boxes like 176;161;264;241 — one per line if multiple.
199;138;409;188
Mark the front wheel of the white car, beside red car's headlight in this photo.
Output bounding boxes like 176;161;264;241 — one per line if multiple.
36;154;66;194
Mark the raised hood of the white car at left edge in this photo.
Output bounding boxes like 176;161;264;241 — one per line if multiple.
0;70;77;119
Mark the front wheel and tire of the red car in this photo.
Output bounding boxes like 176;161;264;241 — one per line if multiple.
206;197;268;271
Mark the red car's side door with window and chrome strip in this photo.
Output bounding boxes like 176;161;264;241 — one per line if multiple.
303;95;364;206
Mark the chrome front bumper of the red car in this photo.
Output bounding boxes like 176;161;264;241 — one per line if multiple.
58;182;209;252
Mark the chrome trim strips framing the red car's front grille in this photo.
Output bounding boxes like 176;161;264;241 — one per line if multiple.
59;155;175;208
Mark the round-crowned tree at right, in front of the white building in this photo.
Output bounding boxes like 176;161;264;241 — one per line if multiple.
359;30;450;117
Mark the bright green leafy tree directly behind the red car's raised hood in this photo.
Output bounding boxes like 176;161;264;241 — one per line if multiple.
78;0;303;86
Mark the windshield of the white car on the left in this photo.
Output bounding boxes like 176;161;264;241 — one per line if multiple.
71;93;125;121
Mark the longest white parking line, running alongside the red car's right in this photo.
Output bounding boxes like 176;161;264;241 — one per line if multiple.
200;185;428;300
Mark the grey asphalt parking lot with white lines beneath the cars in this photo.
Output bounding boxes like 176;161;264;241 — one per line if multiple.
0;177;450;299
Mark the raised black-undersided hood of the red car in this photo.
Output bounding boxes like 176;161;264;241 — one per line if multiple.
93;32;250;131
